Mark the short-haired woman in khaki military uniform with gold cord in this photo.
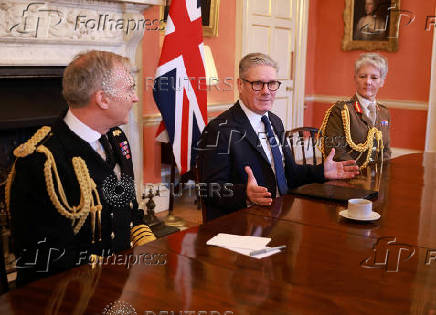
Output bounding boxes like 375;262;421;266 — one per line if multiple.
320;53;391;169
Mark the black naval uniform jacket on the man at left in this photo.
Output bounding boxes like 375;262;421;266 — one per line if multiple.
10;119;143;285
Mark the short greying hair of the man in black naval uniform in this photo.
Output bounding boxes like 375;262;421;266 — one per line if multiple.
62;50;131;108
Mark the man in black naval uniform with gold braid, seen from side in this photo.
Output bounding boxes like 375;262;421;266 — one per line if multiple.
6;51;155;285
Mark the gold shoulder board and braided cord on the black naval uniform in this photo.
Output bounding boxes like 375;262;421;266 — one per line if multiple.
5;127;102;243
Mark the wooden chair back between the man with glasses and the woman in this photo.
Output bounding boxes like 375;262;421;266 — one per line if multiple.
286;127;323;165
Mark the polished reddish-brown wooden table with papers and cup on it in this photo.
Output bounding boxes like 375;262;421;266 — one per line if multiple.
0;154;436;315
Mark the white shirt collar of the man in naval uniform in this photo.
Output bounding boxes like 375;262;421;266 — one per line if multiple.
64;110;121;179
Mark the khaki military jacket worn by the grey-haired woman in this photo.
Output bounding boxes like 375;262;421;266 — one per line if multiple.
323;96;391;166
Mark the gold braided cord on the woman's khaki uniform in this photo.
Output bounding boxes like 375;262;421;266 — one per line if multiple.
318;104;384;170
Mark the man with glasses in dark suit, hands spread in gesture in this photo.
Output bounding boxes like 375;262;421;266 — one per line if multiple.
197;53;358;220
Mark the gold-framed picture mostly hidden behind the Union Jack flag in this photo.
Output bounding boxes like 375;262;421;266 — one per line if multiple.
160;0;220;37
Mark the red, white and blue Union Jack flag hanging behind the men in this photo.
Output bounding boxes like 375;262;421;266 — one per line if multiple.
153;0;207;174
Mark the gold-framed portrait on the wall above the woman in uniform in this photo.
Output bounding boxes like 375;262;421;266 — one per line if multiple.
342;0;400;51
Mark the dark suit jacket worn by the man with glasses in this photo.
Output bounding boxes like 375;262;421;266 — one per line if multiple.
197;102;324;220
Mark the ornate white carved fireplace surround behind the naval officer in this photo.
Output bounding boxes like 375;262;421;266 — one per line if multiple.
0;0;164;193
